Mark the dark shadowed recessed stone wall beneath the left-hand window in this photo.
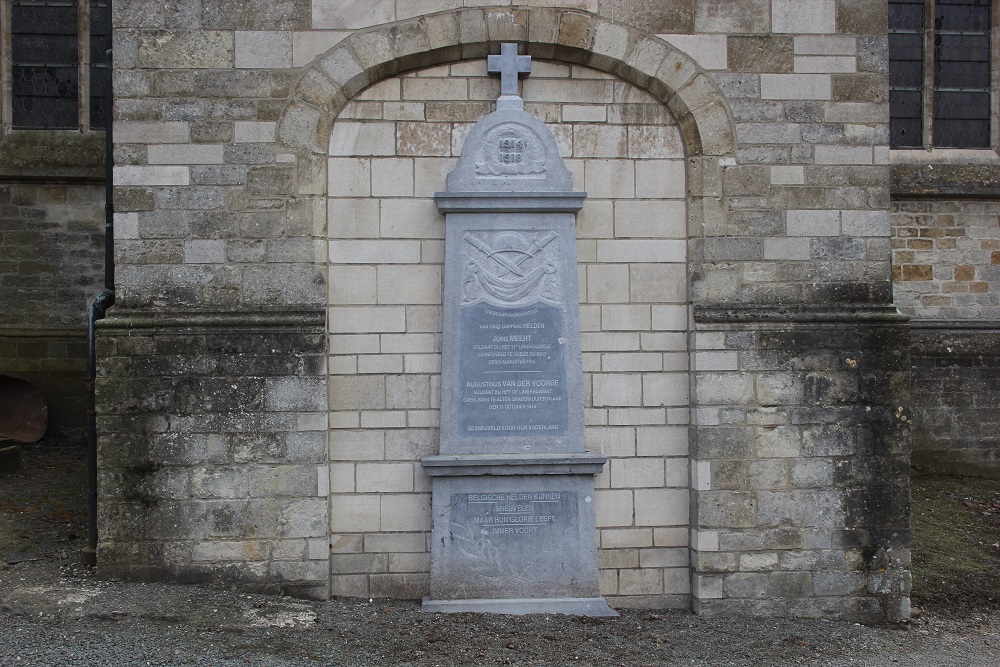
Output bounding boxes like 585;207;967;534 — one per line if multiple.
0;177;104;431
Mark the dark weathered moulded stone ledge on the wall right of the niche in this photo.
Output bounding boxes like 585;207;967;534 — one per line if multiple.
694;304;909;324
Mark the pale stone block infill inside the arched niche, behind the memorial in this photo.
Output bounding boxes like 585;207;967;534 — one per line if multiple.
328;59;690;607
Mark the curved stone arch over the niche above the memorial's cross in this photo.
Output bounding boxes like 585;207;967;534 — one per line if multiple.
278;8;735;160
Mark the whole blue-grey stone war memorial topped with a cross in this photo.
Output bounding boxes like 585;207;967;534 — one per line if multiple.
422;44;615;616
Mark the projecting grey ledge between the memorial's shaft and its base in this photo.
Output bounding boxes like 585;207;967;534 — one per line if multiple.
420;452;608;477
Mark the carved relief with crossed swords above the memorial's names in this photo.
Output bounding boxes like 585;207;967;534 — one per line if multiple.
462;230;562;307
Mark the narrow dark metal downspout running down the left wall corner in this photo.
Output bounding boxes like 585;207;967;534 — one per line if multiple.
80;39;115;566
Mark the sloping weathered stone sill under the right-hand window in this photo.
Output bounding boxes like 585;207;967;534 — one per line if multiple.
889;148;1000;199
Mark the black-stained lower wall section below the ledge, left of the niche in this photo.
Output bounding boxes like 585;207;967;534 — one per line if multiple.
97;309;329;599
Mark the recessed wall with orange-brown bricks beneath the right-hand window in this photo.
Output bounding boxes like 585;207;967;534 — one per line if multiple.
892;181;1000;476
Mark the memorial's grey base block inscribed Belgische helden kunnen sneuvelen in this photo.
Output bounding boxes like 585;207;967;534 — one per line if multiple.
423;453;615;616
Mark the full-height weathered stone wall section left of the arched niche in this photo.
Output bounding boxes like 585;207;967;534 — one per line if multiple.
97;0;329;597
